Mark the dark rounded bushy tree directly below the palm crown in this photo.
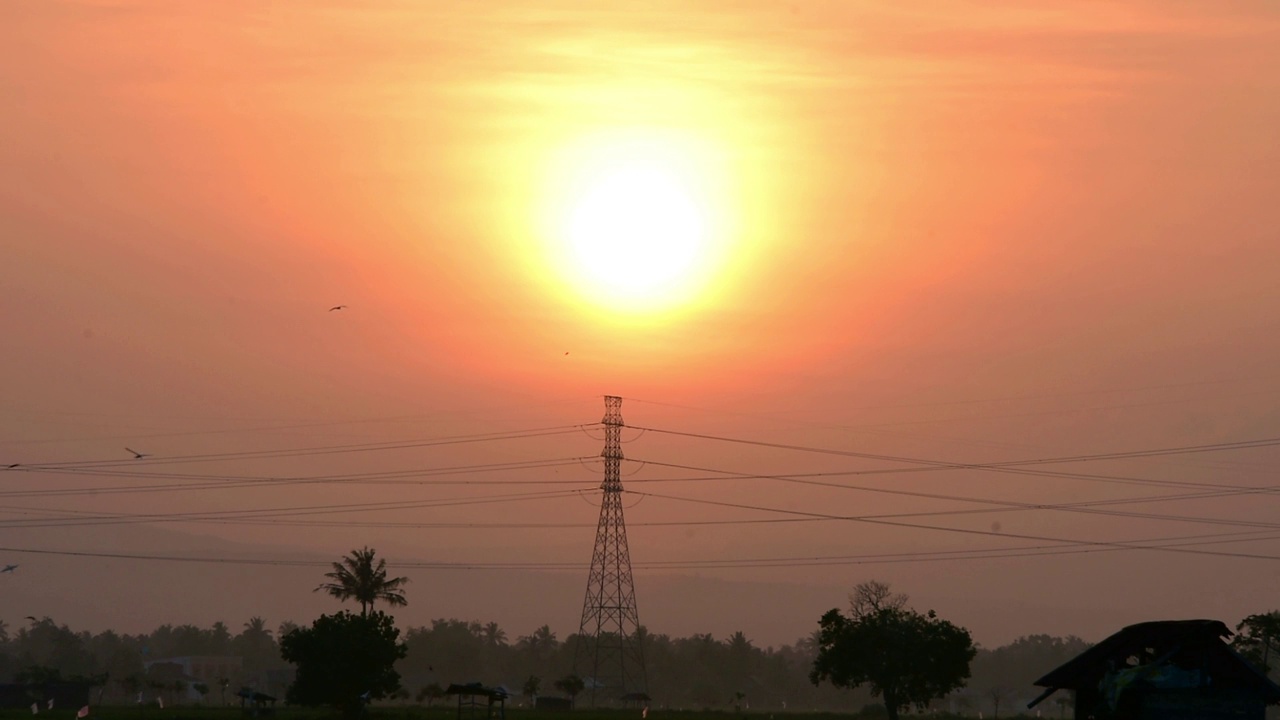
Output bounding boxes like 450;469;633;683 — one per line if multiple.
280;611;407;717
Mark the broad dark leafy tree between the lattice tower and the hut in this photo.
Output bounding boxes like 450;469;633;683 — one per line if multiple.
809;585;977;720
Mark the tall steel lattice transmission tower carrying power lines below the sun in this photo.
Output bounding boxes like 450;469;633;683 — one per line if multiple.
573;396;649;706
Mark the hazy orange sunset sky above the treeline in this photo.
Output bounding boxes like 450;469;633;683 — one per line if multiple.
0;0;1280;644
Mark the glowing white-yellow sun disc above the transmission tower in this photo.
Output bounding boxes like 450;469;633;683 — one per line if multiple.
532;128;724;314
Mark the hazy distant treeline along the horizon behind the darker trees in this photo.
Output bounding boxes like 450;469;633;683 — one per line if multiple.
0;618;1087;716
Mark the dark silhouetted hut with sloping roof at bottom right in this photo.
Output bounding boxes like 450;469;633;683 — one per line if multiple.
1027;620;1280;720
